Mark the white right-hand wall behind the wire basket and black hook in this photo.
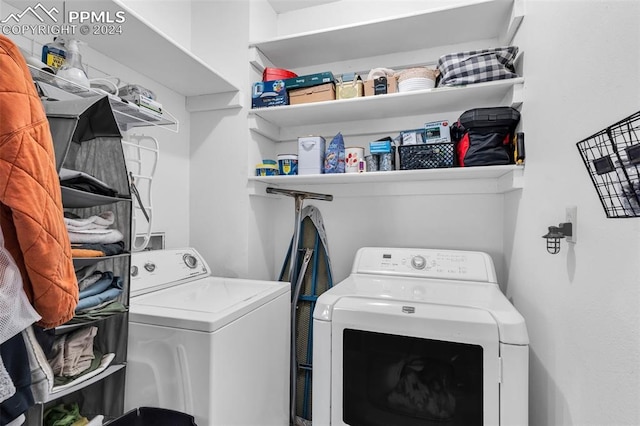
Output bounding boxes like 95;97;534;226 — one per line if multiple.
505;0;640;425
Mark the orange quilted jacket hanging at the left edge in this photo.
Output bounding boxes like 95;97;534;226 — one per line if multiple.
0;35;78;328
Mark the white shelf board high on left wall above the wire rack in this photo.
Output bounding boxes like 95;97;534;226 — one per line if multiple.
32;0;239;97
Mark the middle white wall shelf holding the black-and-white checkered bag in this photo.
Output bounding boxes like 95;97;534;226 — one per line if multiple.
249;77;524;141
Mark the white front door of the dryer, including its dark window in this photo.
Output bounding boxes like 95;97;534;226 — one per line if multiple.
330;297;499;426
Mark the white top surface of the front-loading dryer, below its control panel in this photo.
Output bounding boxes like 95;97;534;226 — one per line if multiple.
313;274;529;345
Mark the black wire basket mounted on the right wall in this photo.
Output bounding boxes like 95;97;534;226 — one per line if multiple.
577;111;640;218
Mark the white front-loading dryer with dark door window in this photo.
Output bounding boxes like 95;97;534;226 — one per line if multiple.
312;247;529;426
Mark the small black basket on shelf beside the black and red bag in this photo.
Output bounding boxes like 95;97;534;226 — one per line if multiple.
398;142;455;170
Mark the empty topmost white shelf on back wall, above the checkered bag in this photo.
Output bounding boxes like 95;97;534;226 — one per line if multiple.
250;0;513;69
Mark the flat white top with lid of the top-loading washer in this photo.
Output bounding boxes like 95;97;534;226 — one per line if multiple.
129;277;290;332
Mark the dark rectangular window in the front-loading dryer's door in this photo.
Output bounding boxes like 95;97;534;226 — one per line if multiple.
342;329;483;426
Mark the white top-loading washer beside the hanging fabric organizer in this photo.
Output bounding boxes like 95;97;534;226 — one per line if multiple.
125;248;291;426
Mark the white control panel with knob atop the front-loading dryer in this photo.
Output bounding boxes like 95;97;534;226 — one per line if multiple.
351;247;497;283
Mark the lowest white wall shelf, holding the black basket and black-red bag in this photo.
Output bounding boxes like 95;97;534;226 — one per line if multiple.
249;165;524;197
